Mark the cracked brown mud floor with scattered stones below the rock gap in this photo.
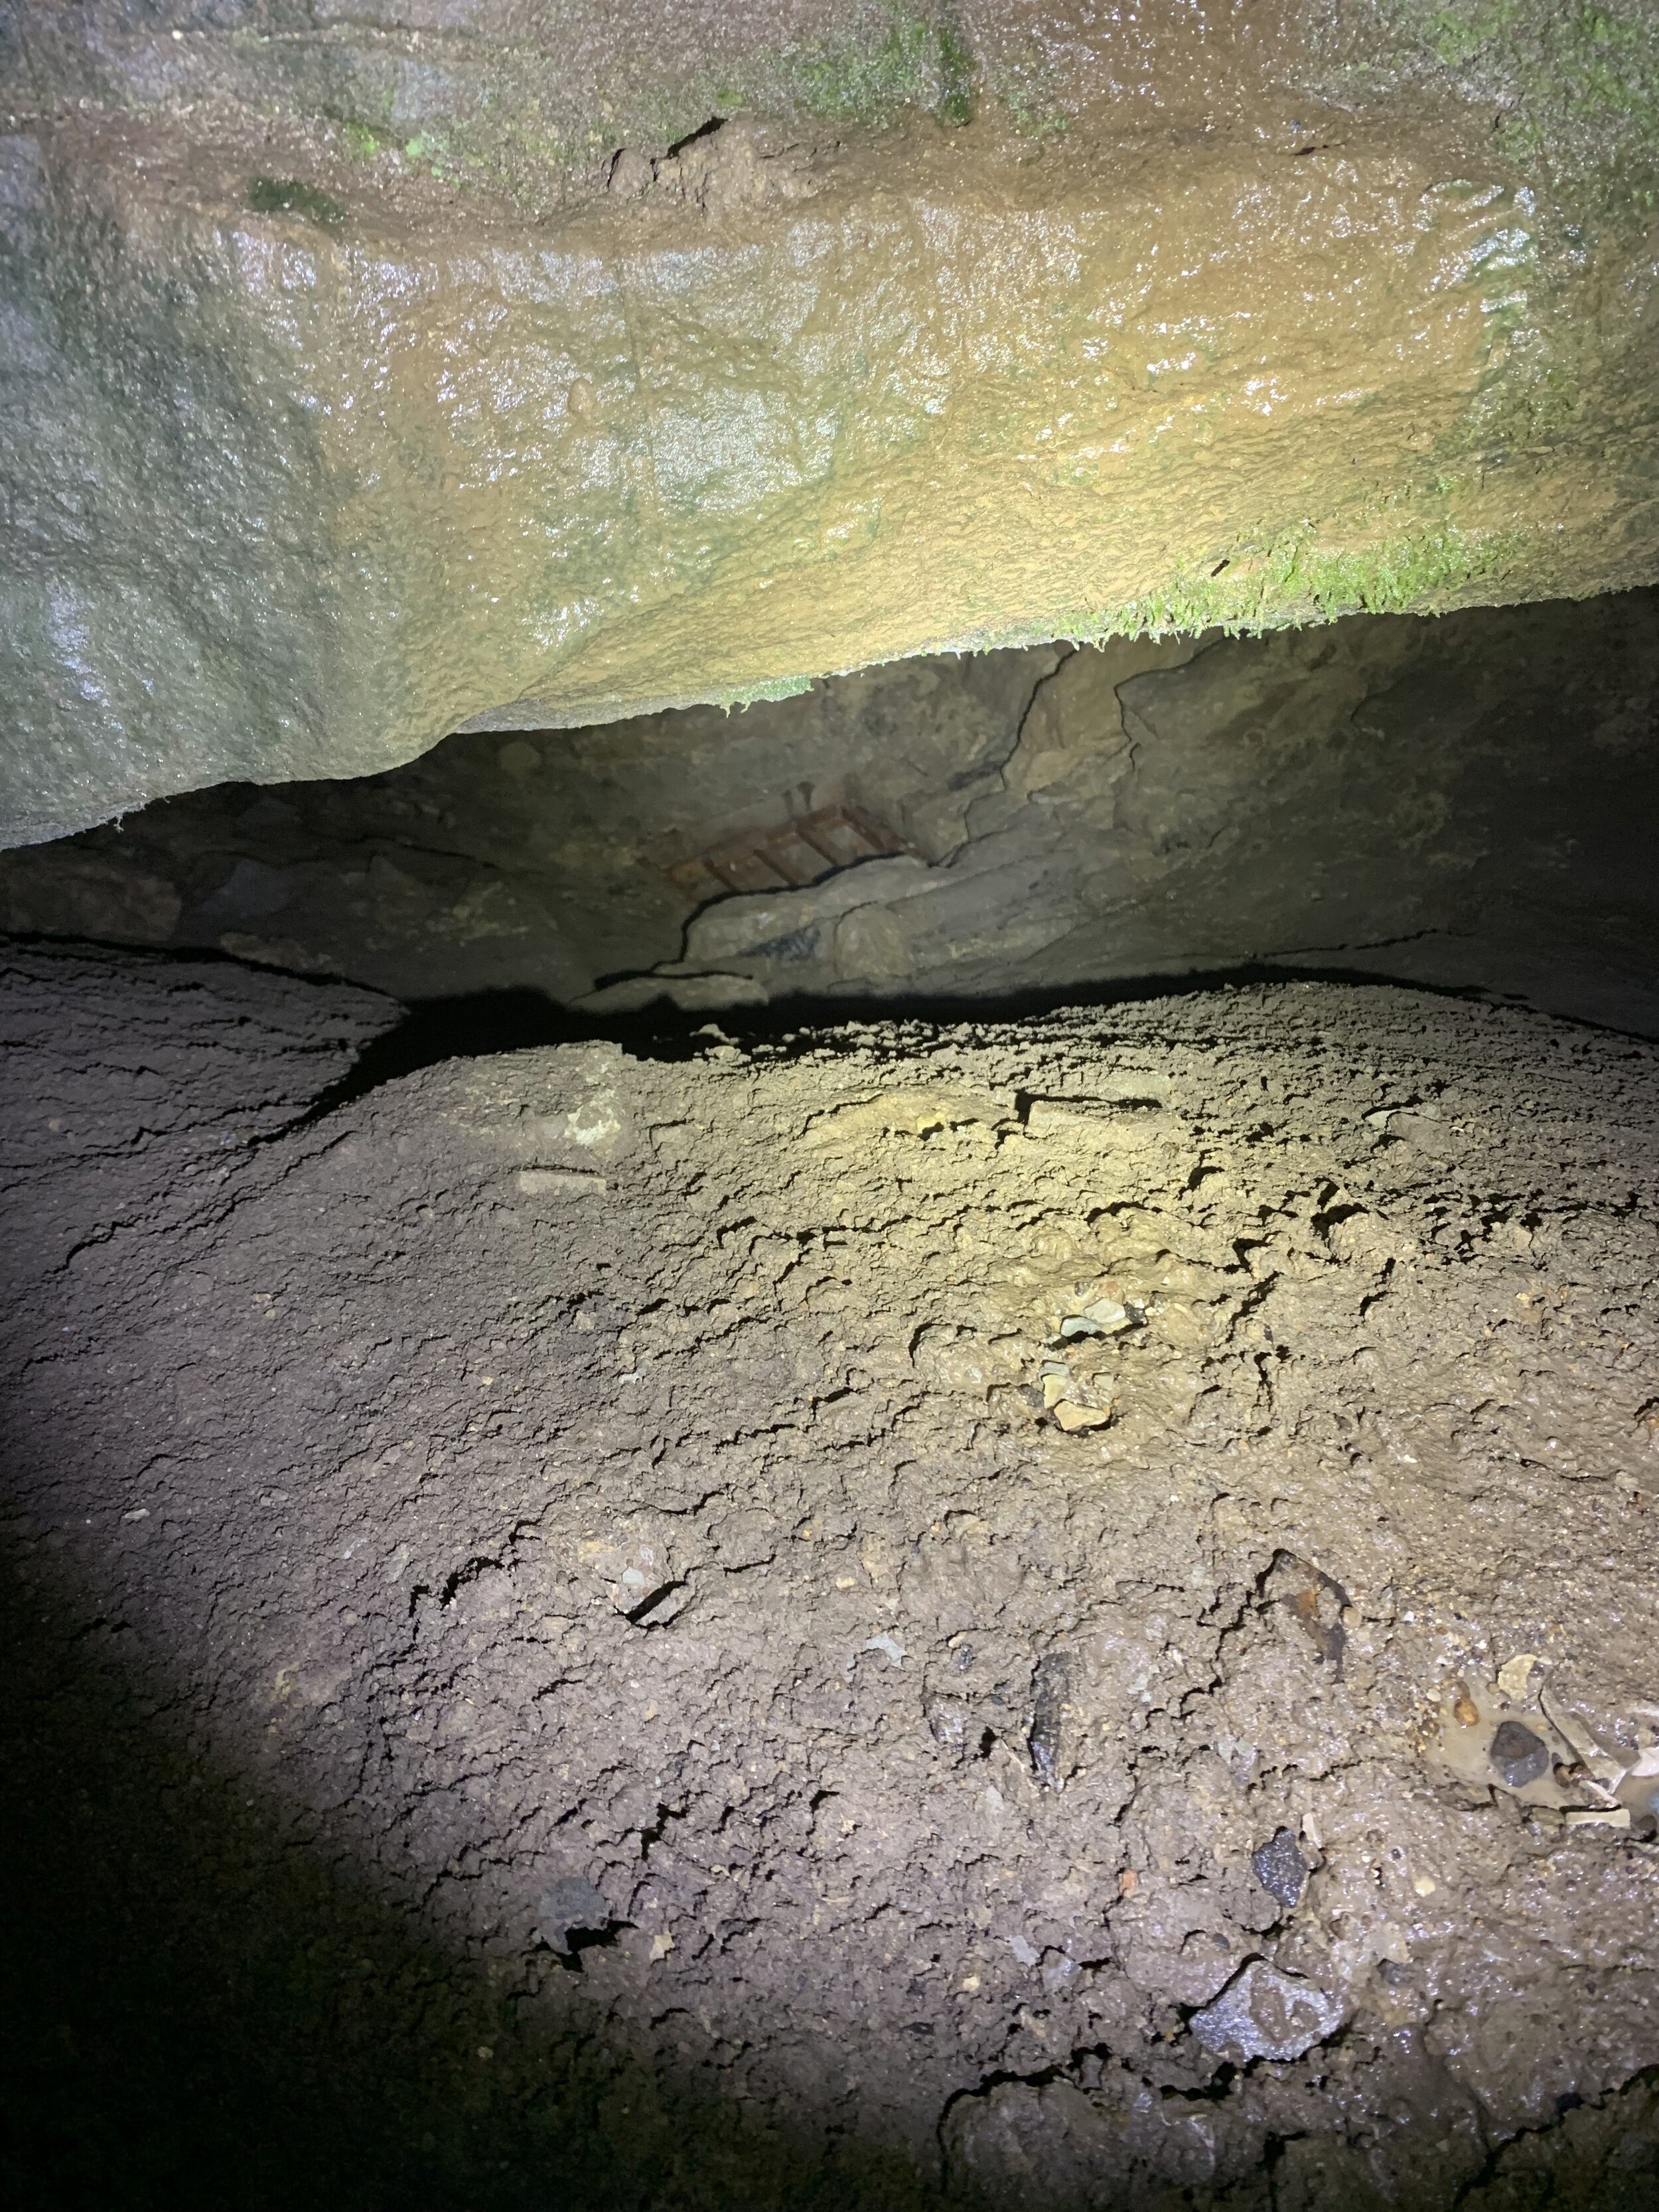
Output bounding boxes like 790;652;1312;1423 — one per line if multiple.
0;949;1659;2212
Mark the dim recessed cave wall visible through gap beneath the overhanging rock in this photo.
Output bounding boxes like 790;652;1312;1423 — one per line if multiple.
0;593;1659;1031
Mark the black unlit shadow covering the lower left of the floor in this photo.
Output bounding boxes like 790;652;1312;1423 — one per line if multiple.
0;1540;942;2212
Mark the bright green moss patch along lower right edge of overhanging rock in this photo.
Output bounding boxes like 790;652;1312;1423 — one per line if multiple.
1075;524;1520;639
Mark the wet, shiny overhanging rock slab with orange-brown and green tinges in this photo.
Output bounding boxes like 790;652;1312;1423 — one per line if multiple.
0;0;1659;845
